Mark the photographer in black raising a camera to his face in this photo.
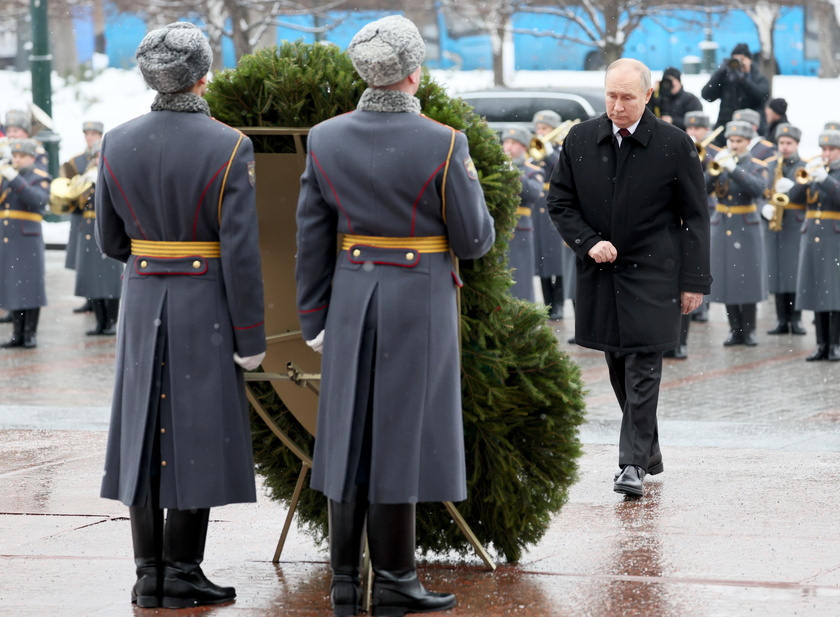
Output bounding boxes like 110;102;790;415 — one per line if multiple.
700;43;770;146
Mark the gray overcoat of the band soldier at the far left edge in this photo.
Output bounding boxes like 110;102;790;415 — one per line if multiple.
0;165;50;311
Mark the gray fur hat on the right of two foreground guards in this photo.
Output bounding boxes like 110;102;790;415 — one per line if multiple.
347;15;426;86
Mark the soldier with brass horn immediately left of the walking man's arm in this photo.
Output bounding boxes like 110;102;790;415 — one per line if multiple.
529;109;574;319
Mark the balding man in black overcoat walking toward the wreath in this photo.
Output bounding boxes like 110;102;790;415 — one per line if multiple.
547;58;711;496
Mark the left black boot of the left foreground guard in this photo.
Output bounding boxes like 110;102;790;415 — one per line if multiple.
128;490;163;608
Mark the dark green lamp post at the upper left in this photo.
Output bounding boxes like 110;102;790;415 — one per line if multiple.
29;0;61;177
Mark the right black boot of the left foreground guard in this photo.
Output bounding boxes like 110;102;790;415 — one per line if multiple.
161;508;236;608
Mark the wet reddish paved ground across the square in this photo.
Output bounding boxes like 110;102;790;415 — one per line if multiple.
0;251;840;617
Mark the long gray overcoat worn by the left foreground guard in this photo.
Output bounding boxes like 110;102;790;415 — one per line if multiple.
96;94;265;509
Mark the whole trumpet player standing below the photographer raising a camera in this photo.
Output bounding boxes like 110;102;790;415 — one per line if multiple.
706;120;767;347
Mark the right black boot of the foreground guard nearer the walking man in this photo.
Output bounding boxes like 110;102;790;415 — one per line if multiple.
368;504;455;617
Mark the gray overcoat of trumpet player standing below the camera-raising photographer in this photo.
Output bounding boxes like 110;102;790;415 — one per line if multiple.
706;158;768;304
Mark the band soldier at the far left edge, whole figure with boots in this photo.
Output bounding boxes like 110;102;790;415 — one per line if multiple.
0;139;50;348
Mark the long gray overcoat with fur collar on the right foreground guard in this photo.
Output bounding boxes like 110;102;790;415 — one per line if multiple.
296;89;494;503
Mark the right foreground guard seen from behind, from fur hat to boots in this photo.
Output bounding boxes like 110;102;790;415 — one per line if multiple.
296;16;494;615
